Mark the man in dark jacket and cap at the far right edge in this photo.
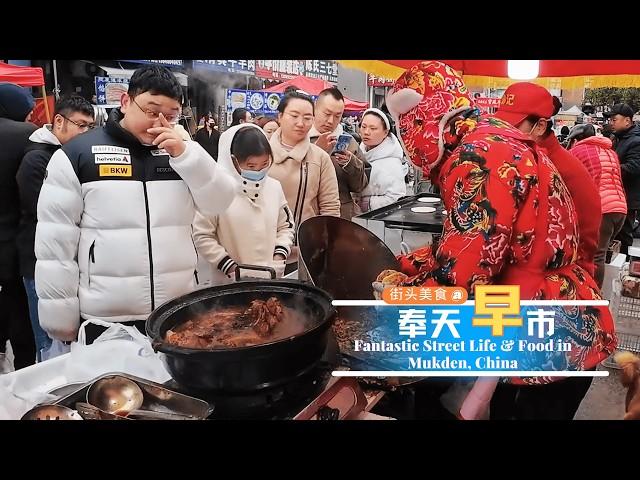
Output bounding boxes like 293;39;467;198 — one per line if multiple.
605;103;640;254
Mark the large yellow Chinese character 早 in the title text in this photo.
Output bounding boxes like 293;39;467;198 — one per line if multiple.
471;285;522;337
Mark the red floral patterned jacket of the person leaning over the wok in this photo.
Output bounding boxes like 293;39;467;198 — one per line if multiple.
398;117;616;384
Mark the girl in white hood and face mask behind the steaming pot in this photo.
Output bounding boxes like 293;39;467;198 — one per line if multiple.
193;124;294;285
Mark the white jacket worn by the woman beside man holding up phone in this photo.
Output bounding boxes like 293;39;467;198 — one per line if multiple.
360;134;407;211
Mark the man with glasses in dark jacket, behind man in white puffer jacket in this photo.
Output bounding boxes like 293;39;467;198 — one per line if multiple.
16;95;94;360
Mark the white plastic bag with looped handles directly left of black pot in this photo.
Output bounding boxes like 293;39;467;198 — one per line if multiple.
65;319;171;383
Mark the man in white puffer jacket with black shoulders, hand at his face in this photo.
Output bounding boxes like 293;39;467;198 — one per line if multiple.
35;66;237;341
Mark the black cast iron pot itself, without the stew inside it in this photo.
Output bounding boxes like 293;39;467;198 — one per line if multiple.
146;279;335;394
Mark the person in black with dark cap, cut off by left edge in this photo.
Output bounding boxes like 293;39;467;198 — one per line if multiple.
0;83;36;369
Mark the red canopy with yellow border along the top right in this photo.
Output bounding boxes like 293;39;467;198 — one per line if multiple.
338;60;640;88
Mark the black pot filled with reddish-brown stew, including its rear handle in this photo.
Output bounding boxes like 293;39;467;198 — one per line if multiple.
146;265;335;394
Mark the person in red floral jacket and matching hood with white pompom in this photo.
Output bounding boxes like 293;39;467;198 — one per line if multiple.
385;61;616;418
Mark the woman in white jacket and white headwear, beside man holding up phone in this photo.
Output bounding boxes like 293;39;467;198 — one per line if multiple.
358;108;407;212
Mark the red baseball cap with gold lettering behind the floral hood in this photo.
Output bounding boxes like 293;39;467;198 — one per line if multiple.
494;82;556;126
